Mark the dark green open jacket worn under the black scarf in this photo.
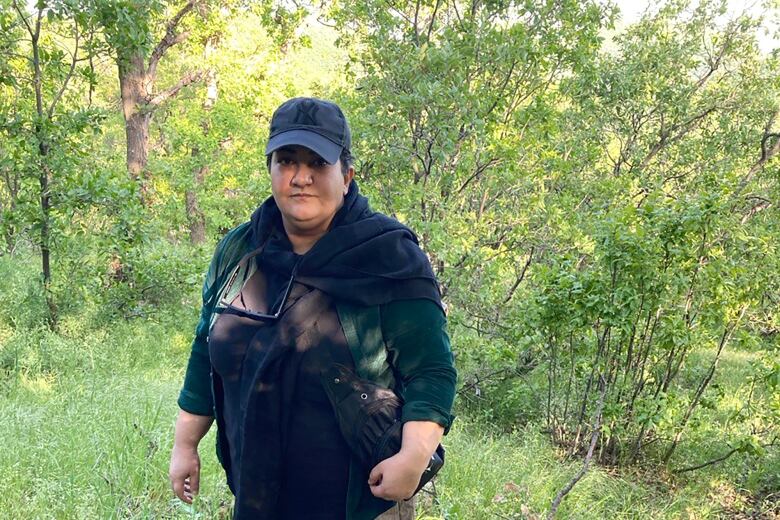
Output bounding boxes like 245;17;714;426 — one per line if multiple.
178;223;457;520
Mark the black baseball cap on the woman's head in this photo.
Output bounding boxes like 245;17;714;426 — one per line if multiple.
265;97;352;164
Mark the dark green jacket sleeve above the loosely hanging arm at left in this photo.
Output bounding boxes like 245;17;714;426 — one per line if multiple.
178;224;247;415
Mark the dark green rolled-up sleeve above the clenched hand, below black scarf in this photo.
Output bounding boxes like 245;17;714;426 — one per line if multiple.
381;299;457;432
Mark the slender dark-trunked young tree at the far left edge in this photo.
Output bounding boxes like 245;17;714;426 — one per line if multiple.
3;0;105;326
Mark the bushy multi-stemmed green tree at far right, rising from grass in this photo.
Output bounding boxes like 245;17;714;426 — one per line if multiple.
537;2;778;462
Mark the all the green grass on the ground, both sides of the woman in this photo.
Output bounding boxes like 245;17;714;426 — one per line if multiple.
0;254;780;520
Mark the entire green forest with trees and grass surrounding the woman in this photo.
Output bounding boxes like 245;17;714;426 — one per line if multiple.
0;0;780;520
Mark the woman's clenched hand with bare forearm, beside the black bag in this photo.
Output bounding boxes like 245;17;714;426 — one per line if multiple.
368;421;444;502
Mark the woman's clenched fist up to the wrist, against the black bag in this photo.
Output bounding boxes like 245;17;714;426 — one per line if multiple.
368;450;430;502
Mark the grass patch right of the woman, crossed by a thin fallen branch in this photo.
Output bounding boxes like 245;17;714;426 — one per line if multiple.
423;423;714;519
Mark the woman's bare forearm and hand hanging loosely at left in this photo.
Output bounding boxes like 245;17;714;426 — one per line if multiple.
168;410;214;504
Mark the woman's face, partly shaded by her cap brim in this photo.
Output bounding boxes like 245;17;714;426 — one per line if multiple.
271;146;354;235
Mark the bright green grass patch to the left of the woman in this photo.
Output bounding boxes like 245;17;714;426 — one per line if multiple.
0;324;228;518
